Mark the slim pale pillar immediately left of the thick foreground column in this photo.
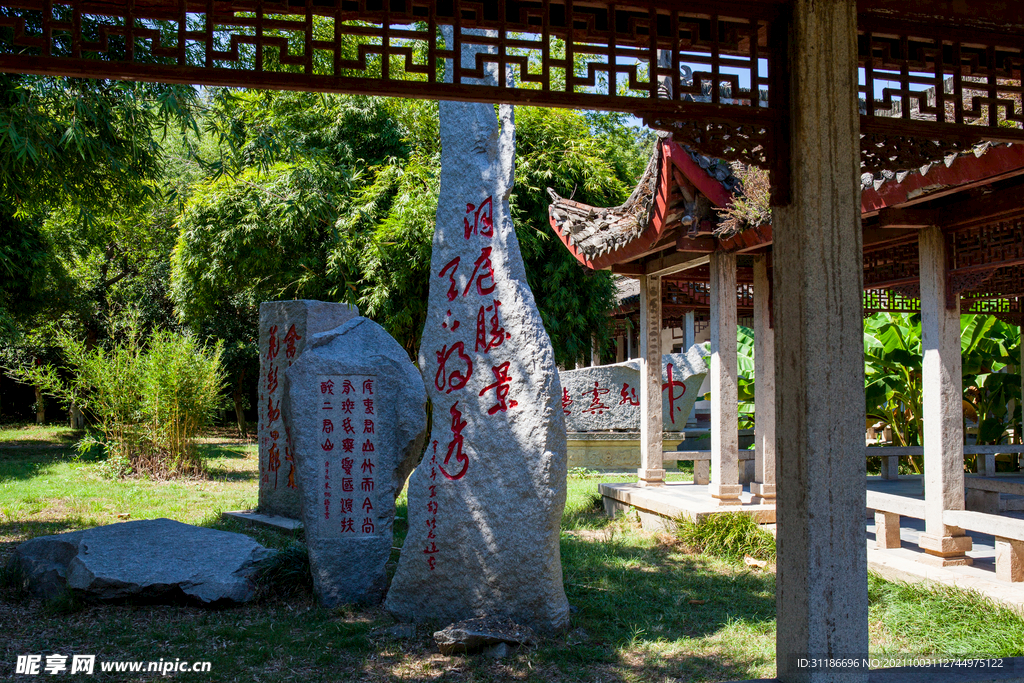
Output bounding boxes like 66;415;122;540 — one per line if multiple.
751;256;775;503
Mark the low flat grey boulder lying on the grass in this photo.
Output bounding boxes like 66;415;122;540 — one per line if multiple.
14;519;274;604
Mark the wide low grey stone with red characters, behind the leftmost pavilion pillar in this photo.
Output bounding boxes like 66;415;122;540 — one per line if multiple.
559;346;708;432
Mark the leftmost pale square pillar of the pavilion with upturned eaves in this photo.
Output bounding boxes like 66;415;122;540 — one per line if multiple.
637;275;665;486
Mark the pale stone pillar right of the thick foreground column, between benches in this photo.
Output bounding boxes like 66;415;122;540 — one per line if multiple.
918;227;971;566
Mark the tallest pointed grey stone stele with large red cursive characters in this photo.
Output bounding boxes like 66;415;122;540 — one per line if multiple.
385;28;569;632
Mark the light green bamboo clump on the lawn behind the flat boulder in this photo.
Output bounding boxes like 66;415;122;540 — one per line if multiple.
10;324;223;476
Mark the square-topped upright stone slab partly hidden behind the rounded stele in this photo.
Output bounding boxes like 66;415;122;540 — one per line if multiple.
257;299;359;519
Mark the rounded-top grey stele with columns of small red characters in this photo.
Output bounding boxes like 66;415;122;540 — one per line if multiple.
284;317;427;607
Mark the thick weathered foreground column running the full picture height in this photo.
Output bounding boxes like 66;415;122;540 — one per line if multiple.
773;0;867;683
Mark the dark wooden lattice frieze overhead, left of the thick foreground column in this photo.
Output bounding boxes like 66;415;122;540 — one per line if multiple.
0;0;785;136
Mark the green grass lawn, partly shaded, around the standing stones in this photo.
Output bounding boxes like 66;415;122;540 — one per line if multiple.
0;432;1024;683
